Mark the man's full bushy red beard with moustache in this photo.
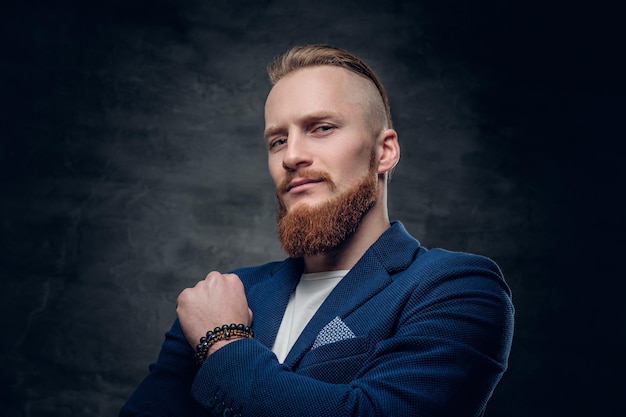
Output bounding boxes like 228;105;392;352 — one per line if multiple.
277;153;377;258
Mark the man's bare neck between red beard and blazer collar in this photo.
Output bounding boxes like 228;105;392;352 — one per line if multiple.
304;204;390;273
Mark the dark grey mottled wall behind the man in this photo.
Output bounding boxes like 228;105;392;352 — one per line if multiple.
0;0;626;417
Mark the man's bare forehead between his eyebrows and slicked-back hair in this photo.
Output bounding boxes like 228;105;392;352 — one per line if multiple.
265;66;375;123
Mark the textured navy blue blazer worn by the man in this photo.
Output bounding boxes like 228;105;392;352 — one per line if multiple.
120;222;513;417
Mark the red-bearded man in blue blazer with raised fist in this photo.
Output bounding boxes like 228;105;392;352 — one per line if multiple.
120;45;513;417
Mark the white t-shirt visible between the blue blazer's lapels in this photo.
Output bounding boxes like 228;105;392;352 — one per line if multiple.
272;270;348;363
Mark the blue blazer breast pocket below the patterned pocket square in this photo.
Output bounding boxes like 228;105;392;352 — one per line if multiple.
295;336;370;384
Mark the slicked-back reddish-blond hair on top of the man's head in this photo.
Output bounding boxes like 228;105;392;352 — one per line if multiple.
267;44;393;129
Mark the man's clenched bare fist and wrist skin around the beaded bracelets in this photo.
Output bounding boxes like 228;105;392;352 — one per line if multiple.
176;271;252;354
